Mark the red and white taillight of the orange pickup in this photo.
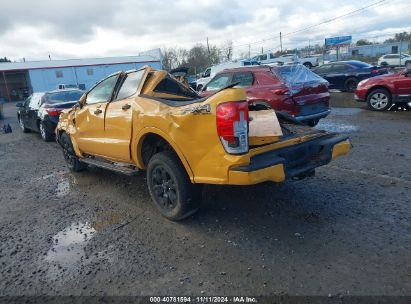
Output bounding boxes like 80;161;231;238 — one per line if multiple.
216;101;249;154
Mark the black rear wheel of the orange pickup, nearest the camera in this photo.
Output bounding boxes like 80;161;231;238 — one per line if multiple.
147;151;201;221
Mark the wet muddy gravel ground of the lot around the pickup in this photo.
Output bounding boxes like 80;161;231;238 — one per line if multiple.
0;100;411;296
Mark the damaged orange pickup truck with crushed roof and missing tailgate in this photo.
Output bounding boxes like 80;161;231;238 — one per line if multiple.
56;67;351;220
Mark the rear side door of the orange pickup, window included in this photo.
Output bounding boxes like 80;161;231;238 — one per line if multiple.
104;70;145;162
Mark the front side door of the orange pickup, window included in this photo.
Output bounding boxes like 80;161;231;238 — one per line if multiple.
74;74;120;156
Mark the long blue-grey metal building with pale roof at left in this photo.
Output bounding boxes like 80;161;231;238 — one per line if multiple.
0;49;162;101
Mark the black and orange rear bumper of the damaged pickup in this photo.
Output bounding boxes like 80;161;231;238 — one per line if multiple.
228;135;351;185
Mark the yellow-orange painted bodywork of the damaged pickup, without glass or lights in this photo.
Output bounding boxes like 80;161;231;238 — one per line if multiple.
57;67;349;185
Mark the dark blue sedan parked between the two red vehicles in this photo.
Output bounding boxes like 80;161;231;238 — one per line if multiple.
313;60;387;92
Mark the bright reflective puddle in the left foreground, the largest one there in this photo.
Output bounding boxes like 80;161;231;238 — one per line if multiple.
46;222;96;267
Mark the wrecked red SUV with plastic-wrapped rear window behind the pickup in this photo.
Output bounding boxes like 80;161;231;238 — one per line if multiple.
199;65;331;126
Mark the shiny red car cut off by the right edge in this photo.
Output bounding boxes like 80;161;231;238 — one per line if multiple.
354;69;411;111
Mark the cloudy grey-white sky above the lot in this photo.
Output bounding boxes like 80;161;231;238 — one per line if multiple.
0;0;411;61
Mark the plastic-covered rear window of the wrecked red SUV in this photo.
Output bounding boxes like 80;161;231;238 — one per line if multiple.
273;64;327;85
